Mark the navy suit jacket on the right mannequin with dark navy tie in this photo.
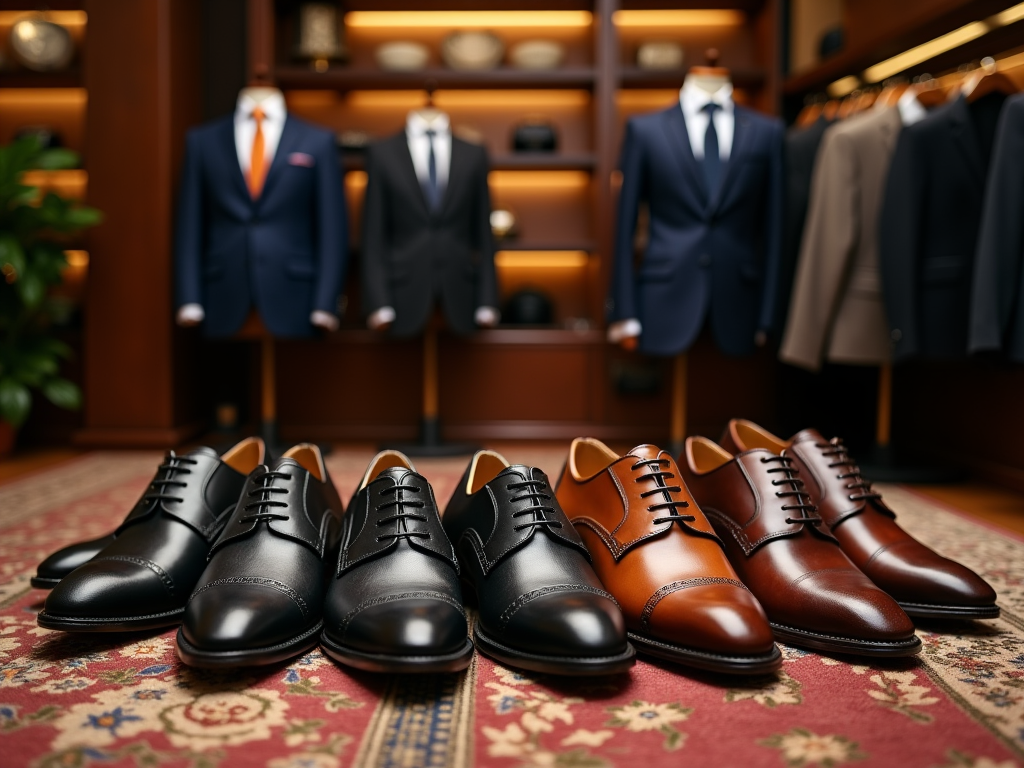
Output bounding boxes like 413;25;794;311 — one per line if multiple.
609;104;783;355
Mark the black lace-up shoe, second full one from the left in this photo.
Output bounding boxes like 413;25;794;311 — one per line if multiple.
177;442;342;667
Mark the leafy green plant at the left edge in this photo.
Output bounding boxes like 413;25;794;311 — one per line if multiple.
0;136;100;455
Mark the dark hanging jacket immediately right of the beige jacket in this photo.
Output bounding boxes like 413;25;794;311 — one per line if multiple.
879;93;1006;360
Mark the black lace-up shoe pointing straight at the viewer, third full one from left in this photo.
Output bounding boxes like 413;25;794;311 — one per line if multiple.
321;451;473;673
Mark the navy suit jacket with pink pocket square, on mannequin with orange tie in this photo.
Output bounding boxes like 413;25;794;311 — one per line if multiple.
174;115;348;337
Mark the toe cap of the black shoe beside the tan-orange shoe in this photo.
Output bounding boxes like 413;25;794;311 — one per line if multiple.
499;591;626;657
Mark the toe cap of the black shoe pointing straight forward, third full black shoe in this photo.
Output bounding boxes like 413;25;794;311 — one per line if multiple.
327;597;469;656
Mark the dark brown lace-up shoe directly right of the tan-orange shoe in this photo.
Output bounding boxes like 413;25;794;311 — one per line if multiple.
680;437;921;656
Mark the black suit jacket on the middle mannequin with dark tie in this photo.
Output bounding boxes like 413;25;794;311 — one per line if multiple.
362;131;498;337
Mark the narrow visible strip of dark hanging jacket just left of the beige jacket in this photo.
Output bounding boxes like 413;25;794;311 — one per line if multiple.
775;115;833;327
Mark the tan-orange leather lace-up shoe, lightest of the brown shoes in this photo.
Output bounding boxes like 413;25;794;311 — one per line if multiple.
556;437;782;674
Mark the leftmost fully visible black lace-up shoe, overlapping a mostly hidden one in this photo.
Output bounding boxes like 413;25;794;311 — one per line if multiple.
37;437;264;632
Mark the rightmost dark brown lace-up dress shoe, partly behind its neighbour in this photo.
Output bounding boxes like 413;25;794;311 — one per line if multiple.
722;419;999;618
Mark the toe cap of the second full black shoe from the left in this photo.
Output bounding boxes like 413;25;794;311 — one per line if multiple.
181;585;312;651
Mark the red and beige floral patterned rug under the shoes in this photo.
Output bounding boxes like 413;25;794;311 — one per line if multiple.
0;446;1024;768
